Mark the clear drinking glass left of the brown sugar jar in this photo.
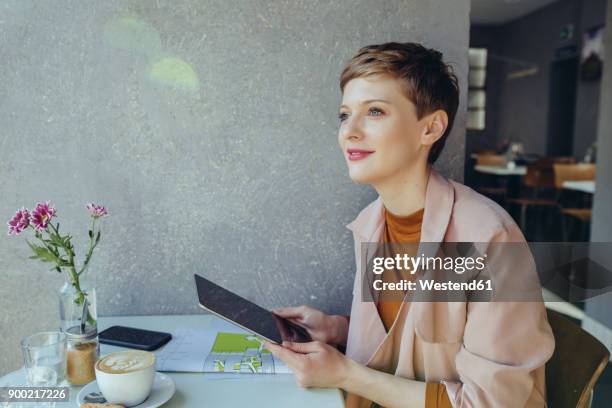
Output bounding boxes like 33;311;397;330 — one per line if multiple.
21;332;66;387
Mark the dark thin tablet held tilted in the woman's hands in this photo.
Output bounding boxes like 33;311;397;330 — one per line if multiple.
194;274;312;344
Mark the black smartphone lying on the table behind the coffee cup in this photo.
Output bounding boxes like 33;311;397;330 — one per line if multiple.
98;326;172;351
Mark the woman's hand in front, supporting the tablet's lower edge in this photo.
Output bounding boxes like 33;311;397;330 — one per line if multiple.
265;341;349;388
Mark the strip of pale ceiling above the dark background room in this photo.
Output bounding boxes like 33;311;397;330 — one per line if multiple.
470;0;556;24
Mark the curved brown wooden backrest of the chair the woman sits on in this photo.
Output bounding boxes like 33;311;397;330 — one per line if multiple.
546;309;610;408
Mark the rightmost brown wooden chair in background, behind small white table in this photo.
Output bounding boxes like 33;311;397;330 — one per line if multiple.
553;163;595;241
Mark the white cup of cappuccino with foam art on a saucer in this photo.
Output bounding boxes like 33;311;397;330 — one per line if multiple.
95;350;155;407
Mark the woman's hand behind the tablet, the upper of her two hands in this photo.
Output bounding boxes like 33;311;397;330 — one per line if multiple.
272;305;348;345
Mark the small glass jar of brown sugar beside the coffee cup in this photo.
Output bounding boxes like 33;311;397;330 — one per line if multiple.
66;326;100;385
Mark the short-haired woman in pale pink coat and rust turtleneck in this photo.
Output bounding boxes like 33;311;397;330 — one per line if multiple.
267;43;554;407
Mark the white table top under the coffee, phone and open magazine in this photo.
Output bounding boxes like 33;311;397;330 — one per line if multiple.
0;314;344;408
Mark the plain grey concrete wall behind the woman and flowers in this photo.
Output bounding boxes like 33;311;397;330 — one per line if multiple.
0;0;469;375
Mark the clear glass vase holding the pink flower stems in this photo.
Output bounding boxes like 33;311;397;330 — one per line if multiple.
59;280;98;333
